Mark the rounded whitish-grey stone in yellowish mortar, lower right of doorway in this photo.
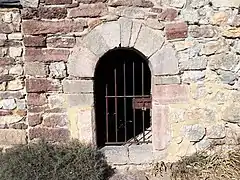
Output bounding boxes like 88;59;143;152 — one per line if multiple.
182;124;206;142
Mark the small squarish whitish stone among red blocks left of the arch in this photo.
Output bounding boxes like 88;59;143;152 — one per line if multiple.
49;62;67;78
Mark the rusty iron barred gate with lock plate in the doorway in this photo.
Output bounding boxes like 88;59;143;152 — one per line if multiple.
105;60;152;145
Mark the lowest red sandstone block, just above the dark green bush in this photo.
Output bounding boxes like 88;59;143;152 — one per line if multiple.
29;128;69;141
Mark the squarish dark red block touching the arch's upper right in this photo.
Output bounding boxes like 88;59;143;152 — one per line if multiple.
165;22;188;40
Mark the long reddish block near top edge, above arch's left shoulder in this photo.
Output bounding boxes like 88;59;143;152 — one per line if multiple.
69;3;108;17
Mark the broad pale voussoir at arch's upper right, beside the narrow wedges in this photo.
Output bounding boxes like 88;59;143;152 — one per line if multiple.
134;26;164;57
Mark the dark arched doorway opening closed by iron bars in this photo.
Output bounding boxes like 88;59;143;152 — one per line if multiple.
94;48;151;147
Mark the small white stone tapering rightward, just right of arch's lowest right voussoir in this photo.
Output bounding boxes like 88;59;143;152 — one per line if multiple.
182;71;206;83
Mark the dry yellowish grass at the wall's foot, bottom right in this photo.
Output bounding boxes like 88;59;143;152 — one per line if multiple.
153;148;240;180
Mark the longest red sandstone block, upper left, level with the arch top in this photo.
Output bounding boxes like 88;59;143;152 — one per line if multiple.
22;20;86;35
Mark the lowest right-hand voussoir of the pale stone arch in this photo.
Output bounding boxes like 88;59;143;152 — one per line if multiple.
149;45;179;75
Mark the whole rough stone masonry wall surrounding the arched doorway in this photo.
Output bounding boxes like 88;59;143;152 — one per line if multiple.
0;0;240;163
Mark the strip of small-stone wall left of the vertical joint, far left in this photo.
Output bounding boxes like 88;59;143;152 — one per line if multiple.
0;9;28;148
